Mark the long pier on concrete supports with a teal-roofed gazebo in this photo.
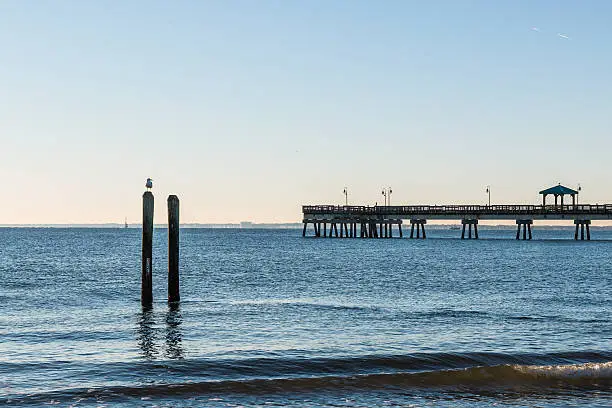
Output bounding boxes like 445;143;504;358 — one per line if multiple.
302;185;612;240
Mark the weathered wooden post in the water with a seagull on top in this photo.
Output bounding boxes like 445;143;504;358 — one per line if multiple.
140;191;154;305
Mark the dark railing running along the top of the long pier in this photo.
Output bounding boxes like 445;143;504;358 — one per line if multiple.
302;204;612;217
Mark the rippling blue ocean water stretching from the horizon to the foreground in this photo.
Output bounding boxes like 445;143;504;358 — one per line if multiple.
0;226;612;407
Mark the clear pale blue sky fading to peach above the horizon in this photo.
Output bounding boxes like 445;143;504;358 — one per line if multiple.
0;0;612;224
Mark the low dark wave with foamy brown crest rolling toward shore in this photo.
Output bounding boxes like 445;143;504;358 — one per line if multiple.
0;352;612;404
